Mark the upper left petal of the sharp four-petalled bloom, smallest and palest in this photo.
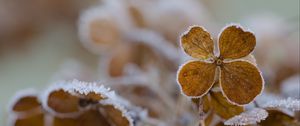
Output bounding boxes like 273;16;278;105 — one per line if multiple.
181;26;214;59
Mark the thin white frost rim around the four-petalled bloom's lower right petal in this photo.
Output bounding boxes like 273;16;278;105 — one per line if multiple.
219;59;265;106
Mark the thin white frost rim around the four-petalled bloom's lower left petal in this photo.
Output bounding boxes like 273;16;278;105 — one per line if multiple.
176;60;217;98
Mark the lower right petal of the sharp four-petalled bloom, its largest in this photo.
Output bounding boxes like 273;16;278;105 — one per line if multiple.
220;61;263;105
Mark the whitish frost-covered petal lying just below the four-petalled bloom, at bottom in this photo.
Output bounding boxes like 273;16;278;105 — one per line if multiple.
225;108;268;125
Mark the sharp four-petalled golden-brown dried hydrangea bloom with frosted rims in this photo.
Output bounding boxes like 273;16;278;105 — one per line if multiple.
177;25;263;105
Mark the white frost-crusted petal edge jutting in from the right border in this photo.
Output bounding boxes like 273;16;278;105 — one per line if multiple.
263;98;300;111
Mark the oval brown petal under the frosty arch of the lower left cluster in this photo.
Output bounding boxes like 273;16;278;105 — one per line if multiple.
47;89;79;113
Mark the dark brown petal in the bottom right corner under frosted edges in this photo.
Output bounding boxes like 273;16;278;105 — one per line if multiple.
259;109;300;126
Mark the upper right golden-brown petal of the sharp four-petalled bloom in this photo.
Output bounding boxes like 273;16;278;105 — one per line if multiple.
219;25;256;59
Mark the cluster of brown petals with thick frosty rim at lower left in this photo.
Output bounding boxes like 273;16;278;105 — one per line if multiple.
9;80;142;126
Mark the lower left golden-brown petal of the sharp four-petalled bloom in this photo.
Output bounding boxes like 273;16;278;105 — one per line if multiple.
177;61;216;97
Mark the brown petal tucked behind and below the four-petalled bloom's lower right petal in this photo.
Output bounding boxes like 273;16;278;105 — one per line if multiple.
209;92;244;119
